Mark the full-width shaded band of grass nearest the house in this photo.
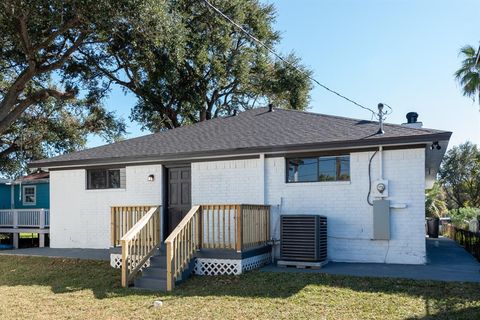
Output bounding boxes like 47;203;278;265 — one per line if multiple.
0;256;480;319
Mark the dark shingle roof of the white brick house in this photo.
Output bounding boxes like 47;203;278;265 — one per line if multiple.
30;108;451;167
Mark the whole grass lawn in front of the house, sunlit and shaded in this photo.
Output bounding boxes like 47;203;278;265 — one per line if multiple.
0;255;480;320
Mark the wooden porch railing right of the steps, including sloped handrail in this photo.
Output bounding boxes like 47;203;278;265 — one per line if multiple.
165;204;270;291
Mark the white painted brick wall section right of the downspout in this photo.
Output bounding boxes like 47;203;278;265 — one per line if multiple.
265;149;425;264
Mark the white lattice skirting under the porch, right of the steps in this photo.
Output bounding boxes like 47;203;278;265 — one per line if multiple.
193;253;272;276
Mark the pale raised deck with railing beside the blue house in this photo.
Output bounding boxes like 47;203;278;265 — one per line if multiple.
0;209;50;248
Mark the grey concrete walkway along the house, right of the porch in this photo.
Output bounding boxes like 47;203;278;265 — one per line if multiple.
262;238;480;282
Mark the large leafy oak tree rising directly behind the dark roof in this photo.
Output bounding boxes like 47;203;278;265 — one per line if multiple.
83;0;311;131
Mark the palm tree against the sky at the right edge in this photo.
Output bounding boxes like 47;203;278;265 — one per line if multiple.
455;45;480;103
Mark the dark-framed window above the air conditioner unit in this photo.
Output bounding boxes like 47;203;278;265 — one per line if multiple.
287;155;350;183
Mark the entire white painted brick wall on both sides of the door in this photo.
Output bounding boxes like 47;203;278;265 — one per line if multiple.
50;149;425;264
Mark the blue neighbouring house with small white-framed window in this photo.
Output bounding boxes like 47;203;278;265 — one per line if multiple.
0;172;50;209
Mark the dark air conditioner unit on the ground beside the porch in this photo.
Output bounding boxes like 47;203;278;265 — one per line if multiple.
280;215;327;262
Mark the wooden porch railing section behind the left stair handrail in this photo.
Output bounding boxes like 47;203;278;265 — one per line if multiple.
110;206;152;247
